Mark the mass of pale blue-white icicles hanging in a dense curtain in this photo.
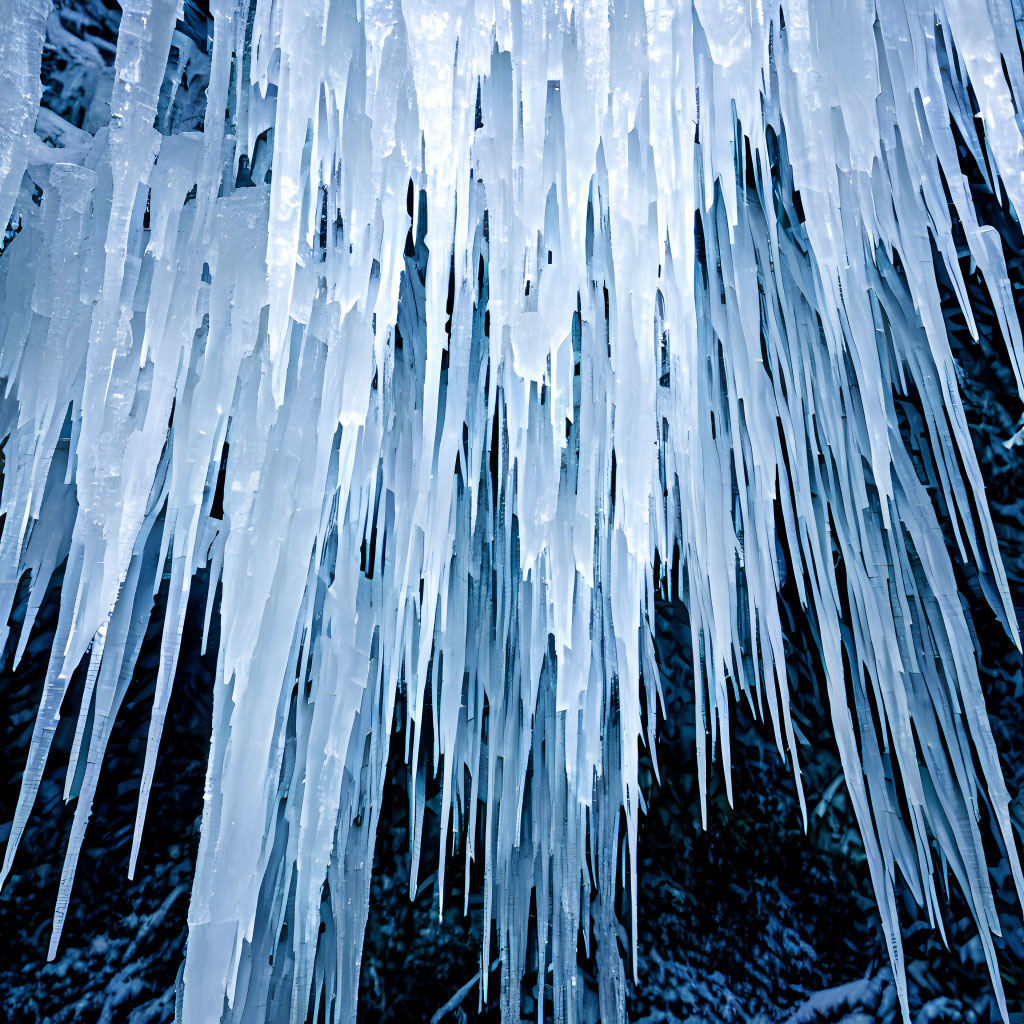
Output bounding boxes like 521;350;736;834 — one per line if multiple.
0;0;1024;1024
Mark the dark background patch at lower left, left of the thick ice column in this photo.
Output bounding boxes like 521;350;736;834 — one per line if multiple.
0;565;213;1024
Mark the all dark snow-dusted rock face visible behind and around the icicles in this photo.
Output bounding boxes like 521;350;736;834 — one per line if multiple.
0;0;1024;1024
